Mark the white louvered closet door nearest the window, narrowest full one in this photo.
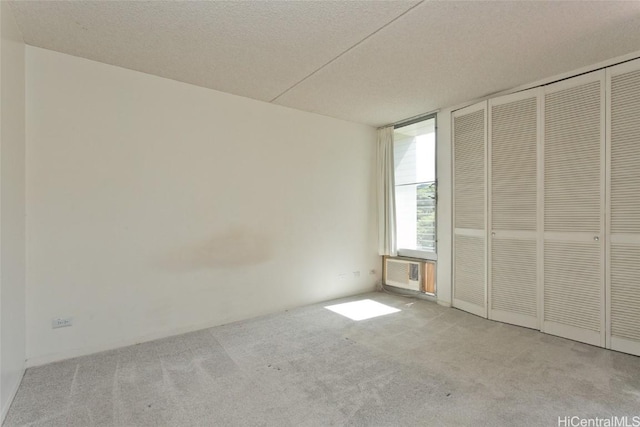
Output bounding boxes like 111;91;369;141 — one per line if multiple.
452;102;487;317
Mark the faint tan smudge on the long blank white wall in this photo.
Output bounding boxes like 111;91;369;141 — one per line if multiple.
160;227;273;271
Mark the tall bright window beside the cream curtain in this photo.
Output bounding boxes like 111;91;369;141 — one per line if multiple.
393;116;436;259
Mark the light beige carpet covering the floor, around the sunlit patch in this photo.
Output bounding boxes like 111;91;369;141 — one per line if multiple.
5;293;640;427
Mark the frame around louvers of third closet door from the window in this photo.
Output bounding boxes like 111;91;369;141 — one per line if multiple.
538;70;609;347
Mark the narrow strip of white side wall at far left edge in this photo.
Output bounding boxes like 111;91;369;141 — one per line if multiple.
0;1;25;422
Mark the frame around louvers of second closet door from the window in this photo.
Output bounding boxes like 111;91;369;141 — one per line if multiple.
486;87;544;329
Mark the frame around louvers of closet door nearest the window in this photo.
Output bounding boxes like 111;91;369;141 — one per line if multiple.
451;101;488;318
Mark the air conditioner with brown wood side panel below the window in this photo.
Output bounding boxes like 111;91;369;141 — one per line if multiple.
384;257;436;294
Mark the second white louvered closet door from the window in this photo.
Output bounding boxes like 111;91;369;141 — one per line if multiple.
488;88;541;329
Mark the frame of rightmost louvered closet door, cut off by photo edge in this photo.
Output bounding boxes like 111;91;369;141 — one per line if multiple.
605;59;640;355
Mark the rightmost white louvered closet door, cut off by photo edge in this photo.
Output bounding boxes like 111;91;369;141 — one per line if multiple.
607;61;640;355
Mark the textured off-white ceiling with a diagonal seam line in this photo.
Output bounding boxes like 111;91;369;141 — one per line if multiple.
11;1;640;126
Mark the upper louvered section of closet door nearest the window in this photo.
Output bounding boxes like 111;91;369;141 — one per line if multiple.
454;109;486;230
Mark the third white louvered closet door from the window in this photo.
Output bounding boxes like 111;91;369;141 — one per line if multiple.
541;71;605;346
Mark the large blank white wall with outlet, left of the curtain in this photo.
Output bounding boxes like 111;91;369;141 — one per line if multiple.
26;47;380;365
